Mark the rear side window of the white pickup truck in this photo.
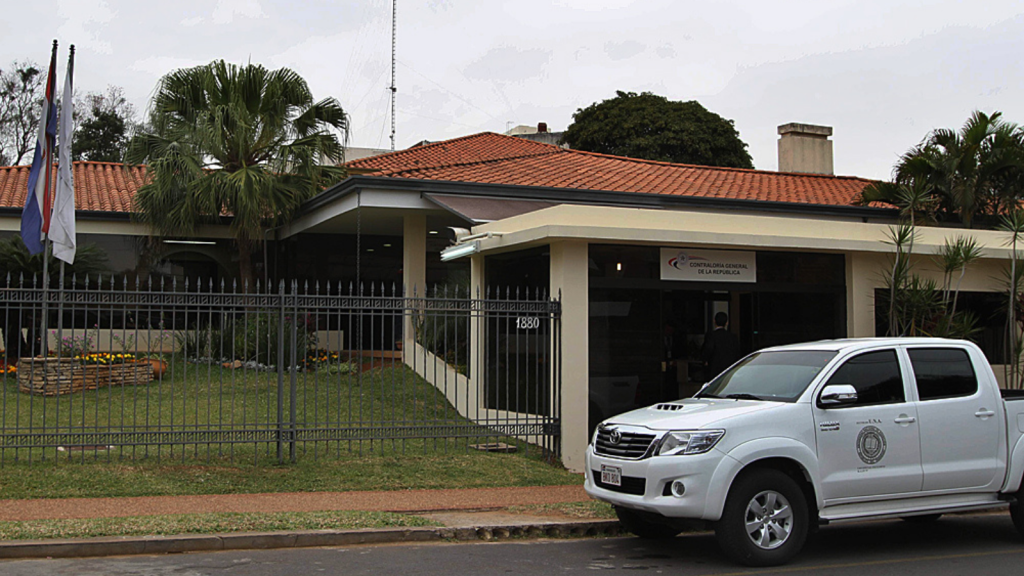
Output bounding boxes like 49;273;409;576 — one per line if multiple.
907;348;978;401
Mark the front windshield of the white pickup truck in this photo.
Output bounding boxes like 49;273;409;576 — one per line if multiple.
696;352;836;402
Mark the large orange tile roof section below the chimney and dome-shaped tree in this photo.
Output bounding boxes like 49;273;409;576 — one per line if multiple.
348;132;873;206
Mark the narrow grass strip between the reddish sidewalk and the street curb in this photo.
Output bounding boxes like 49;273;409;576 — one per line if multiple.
0;511;434;540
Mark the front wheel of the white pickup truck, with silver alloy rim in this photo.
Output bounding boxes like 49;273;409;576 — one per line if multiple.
715;469;810;566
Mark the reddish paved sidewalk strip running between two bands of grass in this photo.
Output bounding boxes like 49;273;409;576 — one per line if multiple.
0;484;590;521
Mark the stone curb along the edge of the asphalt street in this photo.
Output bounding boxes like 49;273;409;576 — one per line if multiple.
0;520;623;559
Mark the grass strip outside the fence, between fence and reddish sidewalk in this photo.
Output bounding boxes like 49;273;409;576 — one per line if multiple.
0;453;582;499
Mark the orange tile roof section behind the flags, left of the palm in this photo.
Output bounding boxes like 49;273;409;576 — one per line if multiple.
0;162;145;213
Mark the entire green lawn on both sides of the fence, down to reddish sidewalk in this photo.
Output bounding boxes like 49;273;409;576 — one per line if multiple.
0;360;581;499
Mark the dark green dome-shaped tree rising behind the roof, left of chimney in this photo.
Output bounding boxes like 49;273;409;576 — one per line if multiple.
562;91;754;168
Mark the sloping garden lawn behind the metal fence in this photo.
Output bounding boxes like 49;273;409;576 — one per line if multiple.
0;360;561;466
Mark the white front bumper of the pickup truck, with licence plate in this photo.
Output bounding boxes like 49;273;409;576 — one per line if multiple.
584;446;738;521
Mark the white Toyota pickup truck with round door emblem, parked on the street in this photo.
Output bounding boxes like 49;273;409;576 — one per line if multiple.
586;338;1024;566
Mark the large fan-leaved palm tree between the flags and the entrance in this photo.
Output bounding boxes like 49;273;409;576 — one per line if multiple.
125;60;348;284
